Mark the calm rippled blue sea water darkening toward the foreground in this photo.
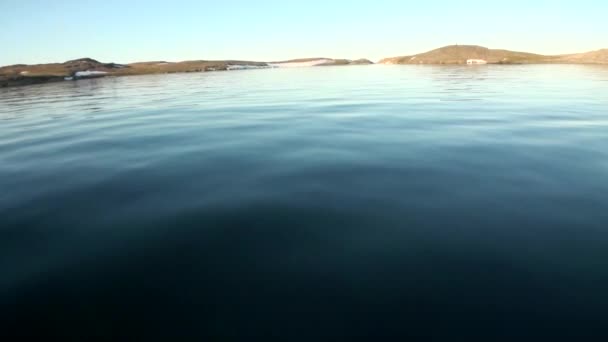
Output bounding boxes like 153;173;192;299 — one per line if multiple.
0;66;608;341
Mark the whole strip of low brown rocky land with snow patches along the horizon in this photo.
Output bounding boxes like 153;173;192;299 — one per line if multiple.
0;45;608;88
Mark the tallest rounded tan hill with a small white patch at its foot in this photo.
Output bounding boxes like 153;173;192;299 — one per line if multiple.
380;45;556;64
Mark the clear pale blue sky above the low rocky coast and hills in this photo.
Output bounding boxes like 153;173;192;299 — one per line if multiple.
0;0;608;65
